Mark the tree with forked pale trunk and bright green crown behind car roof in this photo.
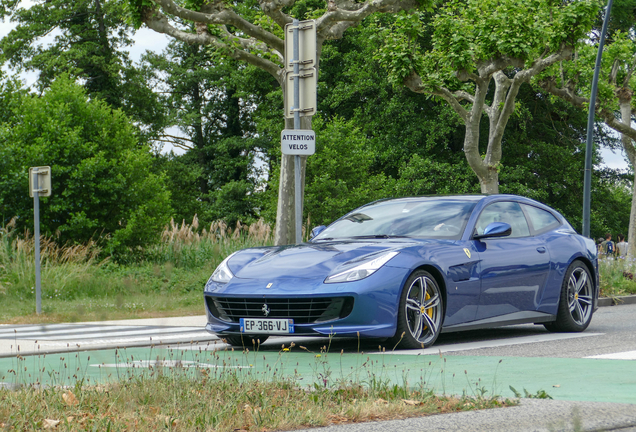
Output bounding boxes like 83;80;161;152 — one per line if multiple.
378;0;597;193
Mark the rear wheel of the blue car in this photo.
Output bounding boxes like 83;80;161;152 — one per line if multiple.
544;261;594;332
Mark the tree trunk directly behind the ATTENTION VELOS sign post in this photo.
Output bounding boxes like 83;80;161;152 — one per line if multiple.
274;117;311;246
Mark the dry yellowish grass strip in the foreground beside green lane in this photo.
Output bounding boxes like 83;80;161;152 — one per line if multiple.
0;373;511;432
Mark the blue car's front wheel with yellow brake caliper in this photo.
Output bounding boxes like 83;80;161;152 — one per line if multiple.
391;270;444;349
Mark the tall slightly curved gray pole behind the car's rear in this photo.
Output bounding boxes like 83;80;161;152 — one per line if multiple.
583;0;613;237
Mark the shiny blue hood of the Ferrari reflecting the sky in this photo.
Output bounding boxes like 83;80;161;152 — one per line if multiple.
228;240;421;279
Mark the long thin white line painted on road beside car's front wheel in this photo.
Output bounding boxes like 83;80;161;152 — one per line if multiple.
376;333;605;355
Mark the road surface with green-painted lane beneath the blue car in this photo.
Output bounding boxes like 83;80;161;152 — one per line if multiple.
0;305;636;432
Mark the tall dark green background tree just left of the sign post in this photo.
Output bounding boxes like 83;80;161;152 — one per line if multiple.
142;40;272;224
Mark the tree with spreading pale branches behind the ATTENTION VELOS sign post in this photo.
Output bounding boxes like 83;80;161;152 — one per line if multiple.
129;0;420;244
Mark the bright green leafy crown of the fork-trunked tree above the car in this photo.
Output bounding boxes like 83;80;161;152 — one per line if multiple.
376;0;598;91
